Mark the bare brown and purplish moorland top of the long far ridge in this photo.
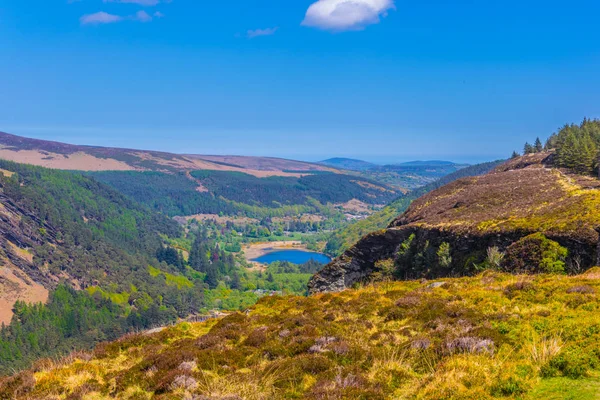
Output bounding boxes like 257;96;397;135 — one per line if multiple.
0;132;336;177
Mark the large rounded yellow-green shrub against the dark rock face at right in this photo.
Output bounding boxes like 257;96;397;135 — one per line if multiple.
502;233;568;273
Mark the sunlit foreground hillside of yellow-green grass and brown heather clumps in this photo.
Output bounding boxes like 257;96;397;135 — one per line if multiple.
0;269;600;400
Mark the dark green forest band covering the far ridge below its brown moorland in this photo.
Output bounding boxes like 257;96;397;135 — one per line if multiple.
91;171;398;218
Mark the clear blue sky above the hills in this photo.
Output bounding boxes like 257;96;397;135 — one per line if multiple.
0;0;600;161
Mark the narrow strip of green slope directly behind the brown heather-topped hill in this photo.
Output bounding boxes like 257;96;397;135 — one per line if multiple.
325;160;504;256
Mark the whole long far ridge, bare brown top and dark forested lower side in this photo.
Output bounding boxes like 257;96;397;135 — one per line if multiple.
0;133;400;219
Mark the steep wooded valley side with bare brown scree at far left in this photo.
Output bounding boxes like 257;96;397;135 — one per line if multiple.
0;160;211;374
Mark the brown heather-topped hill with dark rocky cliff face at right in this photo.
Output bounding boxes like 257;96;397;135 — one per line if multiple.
309;153;600;292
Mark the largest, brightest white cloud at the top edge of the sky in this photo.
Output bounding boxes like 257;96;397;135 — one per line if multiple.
302;0;395;31
